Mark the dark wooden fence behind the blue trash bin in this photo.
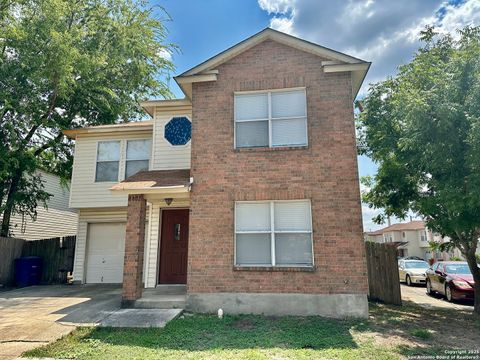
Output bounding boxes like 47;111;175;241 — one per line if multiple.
0;236;76;286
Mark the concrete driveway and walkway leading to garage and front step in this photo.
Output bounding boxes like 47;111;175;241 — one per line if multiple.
0;285;182;360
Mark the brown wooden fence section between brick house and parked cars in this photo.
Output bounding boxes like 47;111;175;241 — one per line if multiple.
365;241;402;305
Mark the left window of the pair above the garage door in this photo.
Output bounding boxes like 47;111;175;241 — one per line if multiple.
95;141;120;182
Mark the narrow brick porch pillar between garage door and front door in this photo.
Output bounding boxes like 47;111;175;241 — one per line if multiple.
122;195;146;307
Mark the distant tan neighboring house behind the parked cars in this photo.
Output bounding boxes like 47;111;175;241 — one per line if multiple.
365;220;463;261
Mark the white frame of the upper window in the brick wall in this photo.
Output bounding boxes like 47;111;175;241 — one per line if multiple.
233;87;308;149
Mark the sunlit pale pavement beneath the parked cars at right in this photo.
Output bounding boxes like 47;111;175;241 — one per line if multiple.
400;283;473;311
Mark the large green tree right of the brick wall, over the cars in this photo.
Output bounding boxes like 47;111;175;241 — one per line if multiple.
358;27;480;315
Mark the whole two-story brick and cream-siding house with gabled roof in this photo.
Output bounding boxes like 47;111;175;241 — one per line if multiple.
65;29;370;317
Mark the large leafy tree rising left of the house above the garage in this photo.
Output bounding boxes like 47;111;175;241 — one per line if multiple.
0;0;174;236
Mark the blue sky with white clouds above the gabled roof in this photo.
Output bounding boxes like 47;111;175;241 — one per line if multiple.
150;0;480;231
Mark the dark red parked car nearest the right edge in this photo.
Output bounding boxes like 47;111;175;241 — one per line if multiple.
427;261;474;301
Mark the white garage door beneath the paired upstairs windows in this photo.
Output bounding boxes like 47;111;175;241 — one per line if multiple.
86;223;125;284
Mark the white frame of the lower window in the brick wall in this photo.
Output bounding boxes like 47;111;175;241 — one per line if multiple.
233;199;315;268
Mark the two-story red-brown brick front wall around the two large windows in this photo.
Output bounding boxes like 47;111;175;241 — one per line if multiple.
187;40;367;294
